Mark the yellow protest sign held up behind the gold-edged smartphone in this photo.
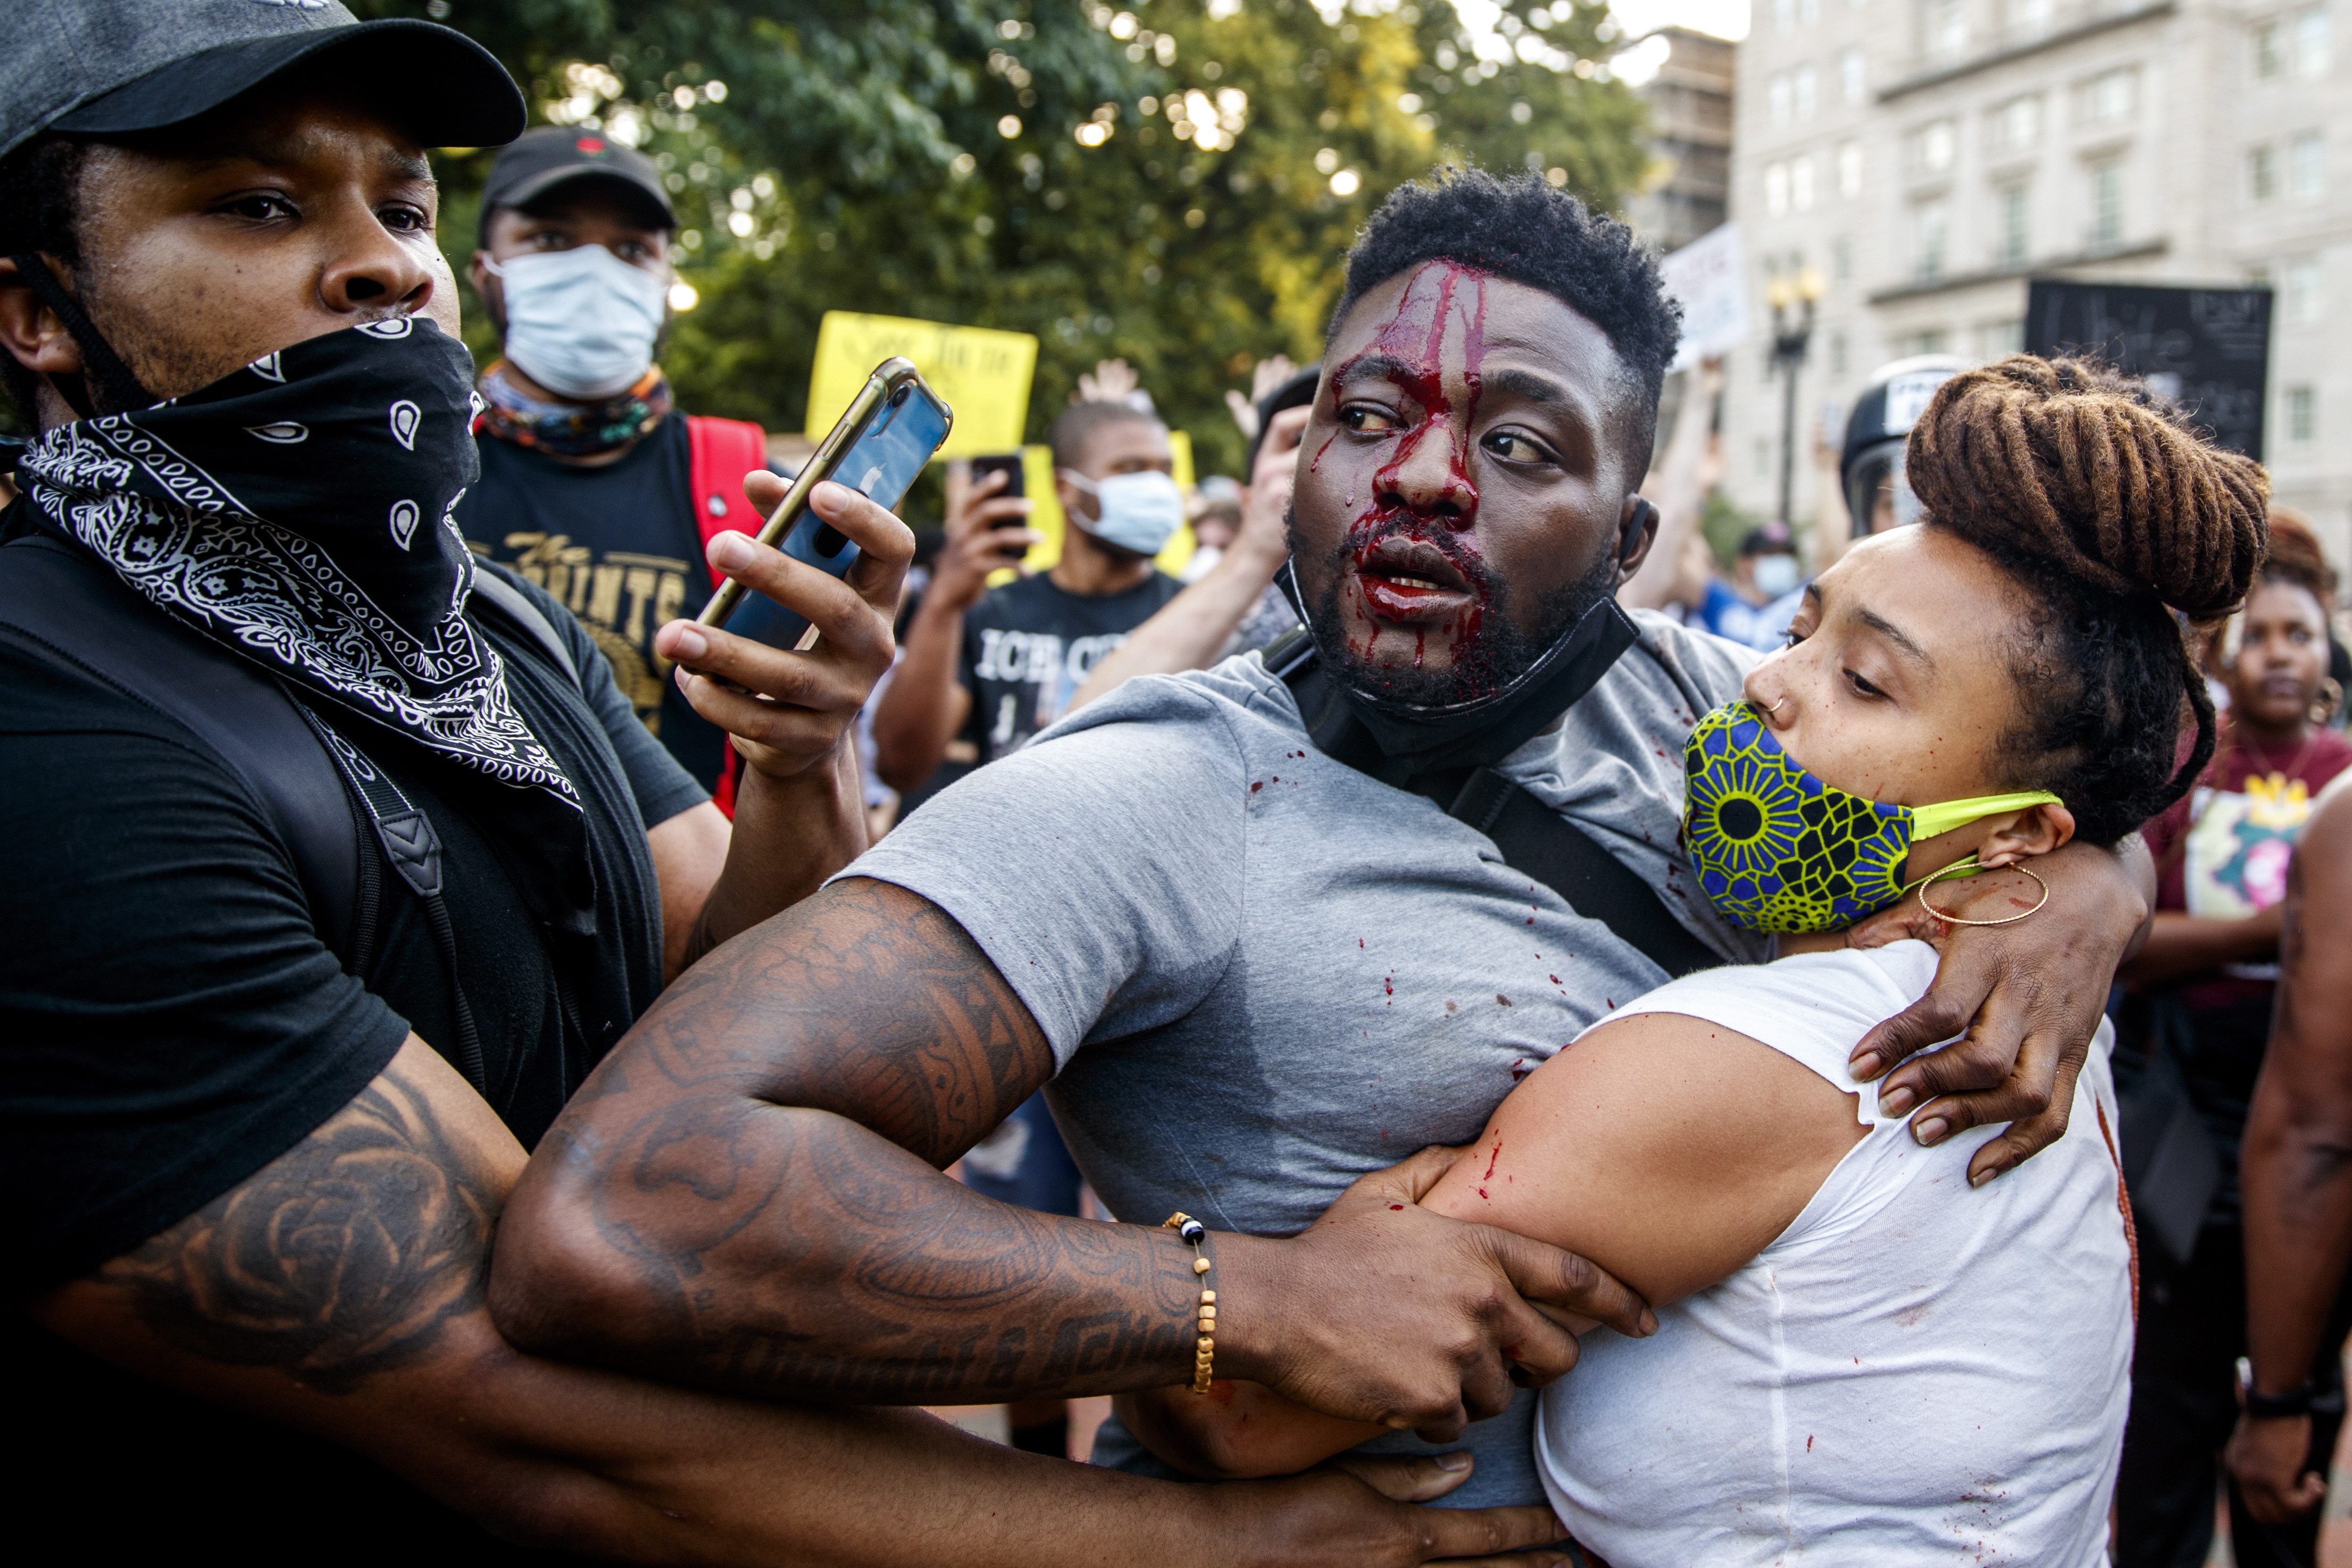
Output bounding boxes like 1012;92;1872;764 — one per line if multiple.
809;310;1037;456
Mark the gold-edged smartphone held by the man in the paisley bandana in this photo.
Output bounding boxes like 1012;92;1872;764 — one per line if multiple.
694;357;955;649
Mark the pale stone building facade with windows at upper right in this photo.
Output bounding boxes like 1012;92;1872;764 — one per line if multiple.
1724;0;2352;566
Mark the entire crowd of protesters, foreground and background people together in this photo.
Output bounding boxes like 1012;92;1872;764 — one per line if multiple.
0;0;2352;1568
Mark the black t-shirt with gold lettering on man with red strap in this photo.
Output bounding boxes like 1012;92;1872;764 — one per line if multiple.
456;414;764;790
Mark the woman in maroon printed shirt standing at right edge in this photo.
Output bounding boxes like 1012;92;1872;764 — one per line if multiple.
2117;510;2352;1568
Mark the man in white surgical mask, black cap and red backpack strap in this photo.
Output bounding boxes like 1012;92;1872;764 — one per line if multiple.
456;127;767;811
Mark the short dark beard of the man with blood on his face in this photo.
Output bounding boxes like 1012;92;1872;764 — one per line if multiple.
1289;508;1618;707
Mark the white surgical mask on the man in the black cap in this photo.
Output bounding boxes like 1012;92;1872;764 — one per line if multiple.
489;245;670;402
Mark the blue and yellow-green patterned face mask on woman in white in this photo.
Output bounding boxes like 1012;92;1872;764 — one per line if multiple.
1682;700;2061;931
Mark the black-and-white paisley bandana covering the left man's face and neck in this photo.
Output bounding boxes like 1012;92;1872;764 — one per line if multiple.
16;315;579;823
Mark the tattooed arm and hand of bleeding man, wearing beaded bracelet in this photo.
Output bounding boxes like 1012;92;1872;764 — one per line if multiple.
491;881;1644;1439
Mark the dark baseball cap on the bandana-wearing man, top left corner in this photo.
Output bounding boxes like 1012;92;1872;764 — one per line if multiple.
0;0;524;155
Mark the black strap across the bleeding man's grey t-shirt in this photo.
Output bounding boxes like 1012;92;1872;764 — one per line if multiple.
1263;628;1724;975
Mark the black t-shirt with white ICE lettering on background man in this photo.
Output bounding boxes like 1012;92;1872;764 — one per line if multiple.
957;571;1183;762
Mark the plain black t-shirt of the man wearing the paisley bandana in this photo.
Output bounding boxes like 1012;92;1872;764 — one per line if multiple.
0;512;703;1563
